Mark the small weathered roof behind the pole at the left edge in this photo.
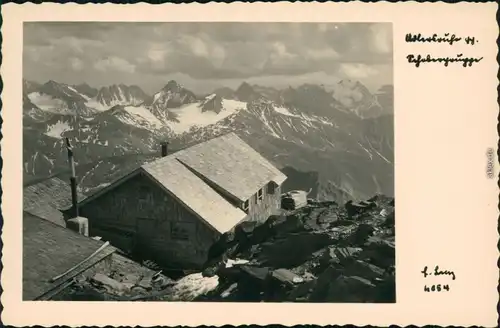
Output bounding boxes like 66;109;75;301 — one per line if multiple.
23;177;85;227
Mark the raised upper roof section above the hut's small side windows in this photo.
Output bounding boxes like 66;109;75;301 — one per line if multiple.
154;133;286;201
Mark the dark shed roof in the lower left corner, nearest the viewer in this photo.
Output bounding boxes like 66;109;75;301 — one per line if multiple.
23;212;116;300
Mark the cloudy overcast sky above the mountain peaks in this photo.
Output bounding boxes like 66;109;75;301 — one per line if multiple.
23;22;393;93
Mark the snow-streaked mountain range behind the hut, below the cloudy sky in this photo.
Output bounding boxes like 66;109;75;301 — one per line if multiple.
23;80;394;201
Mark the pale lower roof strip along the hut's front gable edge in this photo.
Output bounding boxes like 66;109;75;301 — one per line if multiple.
142;156;246;233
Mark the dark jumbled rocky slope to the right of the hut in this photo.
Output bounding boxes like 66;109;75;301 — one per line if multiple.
193;195;395;303
